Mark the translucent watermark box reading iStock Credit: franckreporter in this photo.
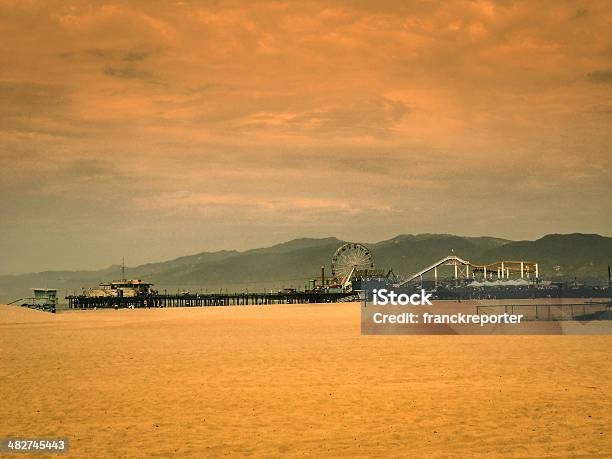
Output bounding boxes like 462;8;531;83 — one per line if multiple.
361;289;612;335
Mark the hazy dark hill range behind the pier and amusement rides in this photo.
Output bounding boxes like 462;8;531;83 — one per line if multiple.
0;234;612;302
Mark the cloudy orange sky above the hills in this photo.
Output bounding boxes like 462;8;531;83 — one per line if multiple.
0;0;612;273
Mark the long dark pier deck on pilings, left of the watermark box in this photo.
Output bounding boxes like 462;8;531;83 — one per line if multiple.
66;292;356;309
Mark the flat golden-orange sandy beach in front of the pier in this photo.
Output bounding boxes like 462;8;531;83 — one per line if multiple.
0;303;612;458
